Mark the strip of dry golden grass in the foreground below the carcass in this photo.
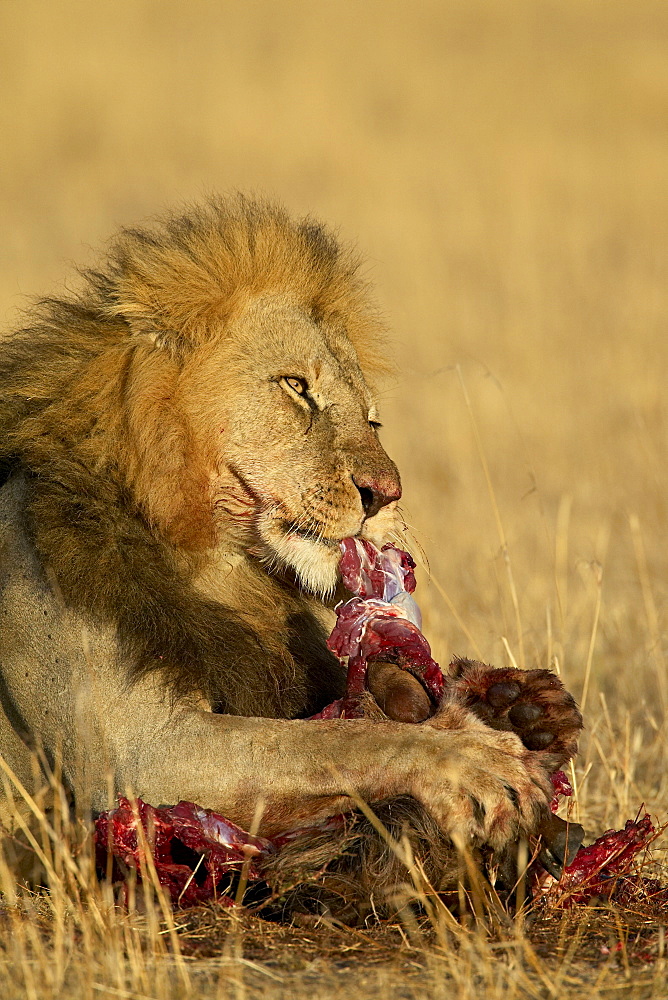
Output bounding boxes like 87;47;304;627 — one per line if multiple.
0;799;666;1000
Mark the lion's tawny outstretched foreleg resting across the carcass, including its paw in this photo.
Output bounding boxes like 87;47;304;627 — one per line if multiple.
105;706;551;847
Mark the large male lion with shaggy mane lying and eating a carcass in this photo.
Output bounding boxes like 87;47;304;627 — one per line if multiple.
0;196;580;916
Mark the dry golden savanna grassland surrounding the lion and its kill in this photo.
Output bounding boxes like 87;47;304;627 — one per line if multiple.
0;0;668;1000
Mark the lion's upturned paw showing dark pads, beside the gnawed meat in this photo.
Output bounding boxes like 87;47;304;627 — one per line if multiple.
446;659;582;771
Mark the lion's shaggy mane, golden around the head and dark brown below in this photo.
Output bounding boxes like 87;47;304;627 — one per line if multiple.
0;191;382;716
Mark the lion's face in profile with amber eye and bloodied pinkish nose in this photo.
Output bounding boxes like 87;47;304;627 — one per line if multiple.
190;298;401;595
